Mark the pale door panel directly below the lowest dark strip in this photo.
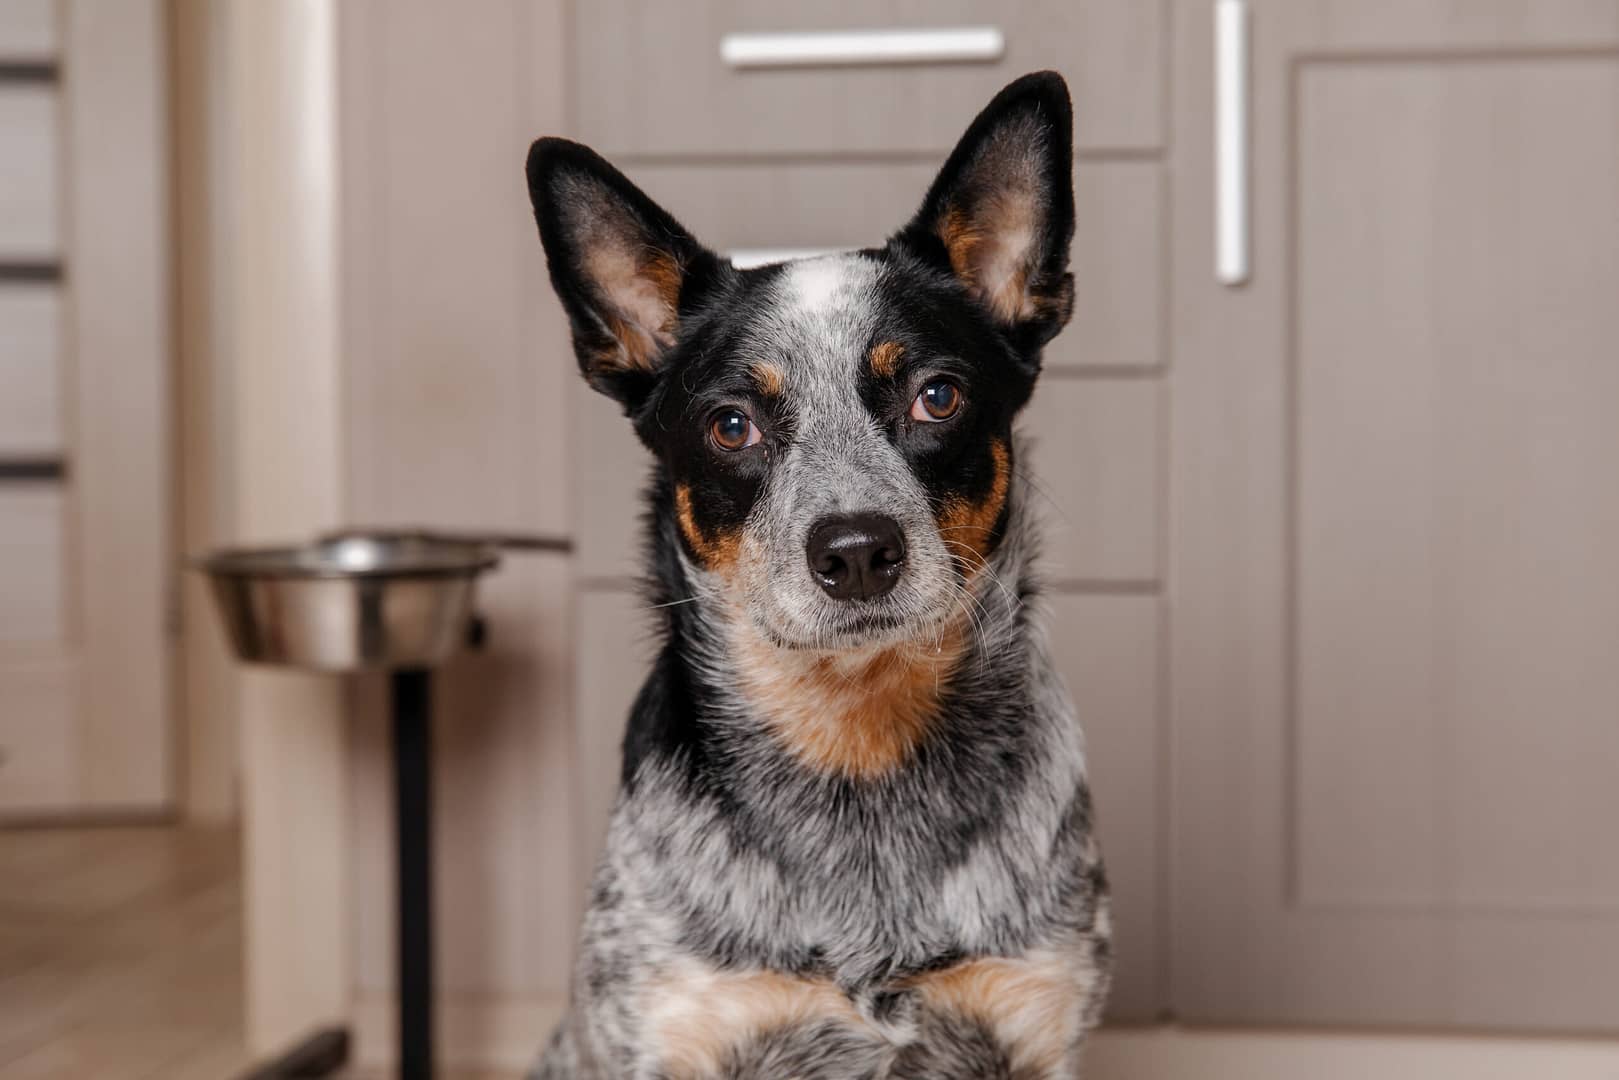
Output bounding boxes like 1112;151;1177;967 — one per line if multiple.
0;483;66;648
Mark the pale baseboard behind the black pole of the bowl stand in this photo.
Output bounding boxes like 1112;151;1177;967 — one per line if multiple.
353;993;567;1070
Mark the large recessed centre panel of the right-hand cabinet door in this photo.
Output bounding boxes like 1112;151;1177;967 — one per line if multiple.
1292;57;1619;908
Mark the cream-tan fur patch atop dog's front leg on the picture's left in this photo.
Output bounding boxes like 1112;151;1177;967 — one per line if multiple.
643;959;873;1080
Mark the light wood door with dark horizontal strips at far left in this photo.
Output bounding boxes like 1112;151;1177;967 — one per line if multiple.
0;0;175;809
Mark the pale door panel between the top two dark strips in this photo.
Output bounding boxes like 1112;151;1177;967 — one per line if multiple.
0;83;60;261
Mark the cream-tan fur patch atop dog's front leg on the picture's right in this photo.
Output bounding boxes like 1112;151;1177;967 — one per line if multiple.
910;949;1098;1077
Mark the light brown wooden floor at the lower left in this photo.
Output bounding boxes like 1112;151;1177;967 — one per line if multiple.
0;827;507;1080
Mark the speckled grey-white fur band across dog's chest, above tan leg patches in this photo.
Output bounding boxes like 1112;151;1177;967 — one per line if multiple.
614;751;1088;988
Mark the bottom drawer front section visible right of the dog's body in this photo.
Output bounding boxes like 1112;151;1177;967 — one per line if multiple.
1047;594;1167;1020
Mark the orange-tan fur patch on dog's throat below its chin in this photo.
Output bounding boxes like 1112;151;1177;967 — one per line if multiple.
732;620;967;779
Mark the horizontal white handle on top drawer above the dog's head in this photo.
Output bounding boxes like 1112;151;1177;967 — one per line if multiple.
719;26;1005;68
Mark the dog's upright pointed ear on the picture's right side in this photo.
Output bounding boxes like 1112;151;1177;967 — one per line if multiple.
899;71;1073;345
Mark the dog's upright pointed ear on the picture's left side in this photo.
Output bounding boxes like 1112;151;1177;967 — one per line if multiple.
528;139;722;411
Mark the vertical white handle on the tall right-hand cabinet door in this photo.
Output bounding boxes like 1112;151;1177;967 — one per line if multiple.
1214;0;1250;285
